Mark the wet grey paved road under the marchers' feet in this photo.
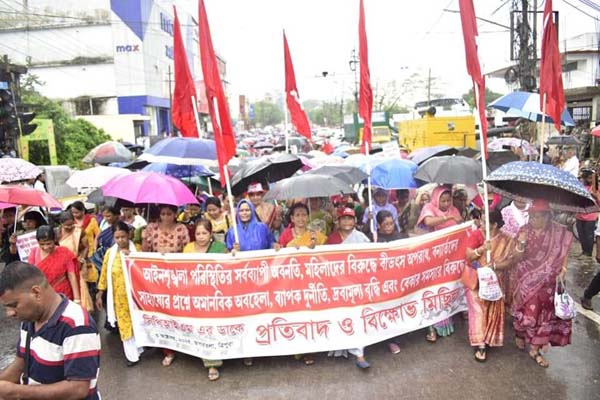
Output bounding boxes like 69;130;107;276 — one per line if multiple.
0;251;600;400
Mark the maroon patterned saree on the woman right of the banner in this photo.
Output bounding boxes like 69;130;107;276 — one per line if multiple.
510;222;573;346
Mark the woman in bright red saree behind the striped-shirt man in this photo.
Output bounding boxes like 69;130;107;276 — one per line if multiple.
27;225;81;304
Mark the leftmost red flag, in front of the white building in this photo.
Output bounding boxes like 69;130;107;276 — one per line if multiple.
171;6;199;138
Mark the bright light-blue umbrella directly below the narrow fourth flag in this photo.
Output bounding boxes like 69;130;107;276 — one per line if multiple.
371;158;418;190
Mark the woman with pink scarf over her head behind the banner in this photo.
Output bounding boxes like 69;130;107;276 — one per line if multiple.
417;186;463;342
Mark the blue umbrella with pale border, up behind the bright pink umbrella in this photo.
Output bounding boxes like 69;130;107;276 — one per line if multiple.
138;137;217;165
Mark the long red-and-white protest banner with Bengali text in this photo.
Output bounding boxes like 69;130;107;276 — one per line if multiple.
125;224;471;359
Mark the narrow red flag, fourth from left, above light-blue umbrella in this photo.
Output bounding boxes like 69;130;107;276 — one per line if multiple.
358;0;373;153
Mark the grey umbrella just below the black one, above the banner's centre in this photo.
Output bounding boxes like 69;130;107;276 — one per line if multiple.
264;174;354;200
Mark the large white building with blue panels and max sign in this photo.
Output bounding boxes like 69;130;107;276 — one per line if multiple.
0;0;225;142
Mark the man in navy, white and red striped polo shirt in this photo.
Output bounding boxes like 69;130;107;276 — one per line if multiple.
0;261;100;400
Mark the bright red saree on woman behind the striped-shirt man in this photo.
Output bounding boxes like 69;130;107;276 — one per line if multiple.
27;246;79;300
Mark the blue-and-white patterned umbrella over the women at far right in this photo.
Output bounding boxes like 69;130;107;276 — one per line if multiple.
486;161;598;213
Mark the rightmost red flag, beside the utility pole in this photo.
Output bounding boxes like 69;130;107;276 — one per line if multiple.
540;0;565;131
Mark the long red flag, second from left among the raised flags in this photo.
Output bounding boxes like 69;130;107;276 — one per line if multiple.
198;0;235;186
